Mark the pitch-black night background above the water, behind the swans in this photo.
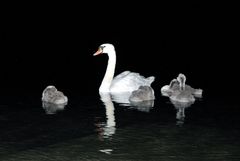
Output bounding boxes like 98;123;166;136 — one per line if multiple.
1;3;237;97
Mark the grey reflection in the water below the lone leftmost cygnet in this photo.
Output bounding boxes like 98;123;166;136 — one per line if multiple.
42;101;67;115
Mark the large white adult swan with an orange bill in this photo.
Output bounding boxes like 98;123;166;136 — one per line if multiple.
94;44;155;94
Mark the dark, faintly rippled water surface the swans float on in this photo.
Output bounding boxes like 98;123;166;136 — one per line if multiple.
0;88;240;161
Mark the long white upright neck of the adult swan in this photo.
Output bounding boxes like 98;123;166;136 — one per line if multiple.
99;50;116;92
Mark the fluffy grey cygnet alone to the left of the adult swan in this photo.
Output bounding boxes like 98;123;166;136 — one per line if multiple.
42;86;68;104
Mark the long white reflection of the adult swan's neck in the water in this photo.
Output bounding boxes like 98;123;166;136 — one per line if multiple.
96;93;116;140
